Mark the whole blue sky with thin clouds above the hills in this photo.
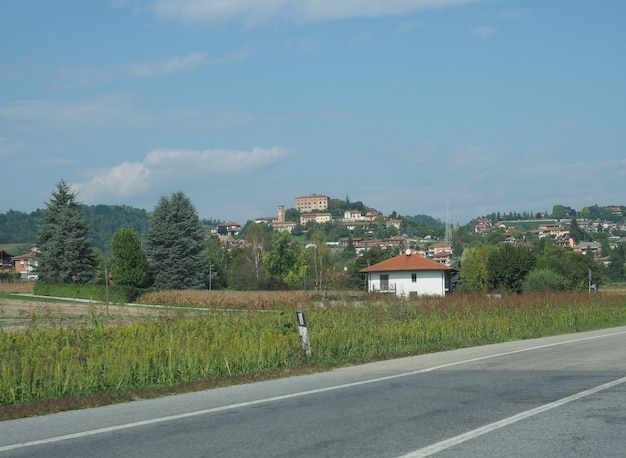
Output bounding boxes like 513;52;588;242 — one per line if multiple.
0;0;626;224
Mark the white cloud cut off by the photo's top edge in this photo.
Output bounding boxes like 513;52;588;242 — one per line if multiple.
153;0;486;26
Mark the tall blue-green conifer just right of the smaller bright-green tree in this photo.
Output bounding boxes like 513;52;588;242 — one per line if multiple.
146;192;208;289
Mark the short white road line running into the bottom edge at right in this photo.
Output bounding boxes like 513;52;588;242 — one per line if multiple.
399;377;626;458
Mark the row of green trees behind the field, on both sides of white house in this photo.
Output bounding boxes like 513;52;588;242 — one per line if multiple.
14;180;625;293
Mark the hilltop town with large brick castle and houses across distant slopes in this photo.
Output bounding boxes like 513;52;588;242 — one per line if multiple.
211;193;626;265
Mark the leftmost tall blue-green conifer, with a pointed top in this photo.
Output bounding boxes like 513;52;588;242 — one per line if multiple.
37;180;97;284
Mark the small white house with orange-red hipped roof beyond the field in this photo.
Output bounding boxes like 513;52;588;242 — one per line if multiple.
361;250;456;297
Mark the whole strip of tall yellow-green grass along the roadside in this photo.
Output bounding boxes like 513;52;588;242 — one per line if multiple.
0;293;626;405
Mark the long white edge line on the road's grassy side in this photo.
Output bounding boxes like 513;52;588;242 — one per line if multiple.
0;331;626;456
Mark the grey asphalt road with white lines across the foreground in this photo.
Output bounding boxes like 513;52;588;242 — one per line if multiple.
0;327;626;458
